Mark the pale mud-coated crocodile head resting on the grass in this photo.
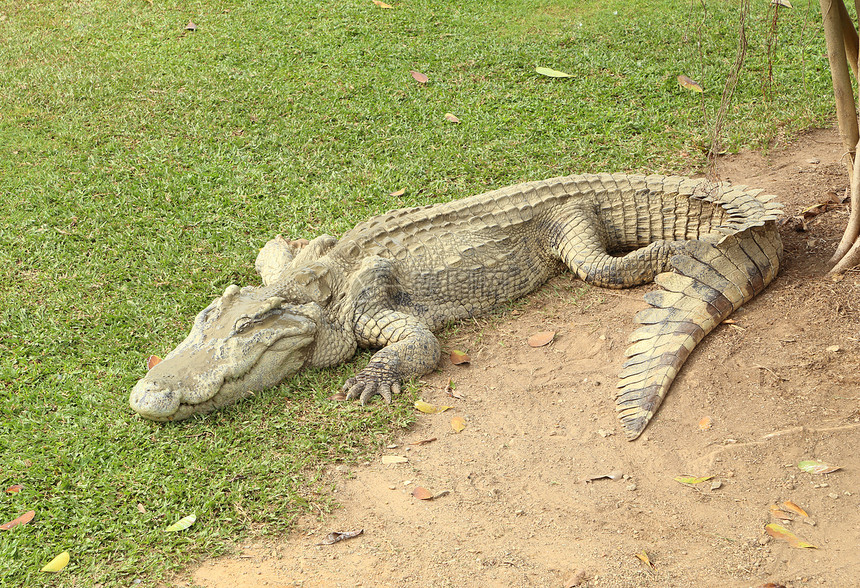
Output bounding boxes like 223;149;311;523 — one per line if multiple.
129;286;321;421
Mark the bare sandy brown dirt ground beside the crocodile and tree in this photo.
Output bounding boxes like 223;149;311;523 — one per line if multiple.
188;130;860;588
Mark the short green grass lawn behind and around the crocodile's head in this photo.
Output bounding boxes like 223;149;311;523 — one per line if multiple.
0;0;832;586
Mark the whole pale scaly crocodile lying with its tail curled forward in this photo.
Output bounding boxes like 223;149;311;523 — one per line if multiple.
130;174;782;440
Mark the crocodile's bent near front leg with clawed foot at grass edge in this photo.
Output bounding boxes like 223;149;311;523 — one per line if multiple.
343;310;442;404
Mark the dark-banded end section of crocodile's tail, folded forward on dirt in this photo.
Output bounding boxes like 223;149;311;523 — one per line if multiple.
615;219;782;441
